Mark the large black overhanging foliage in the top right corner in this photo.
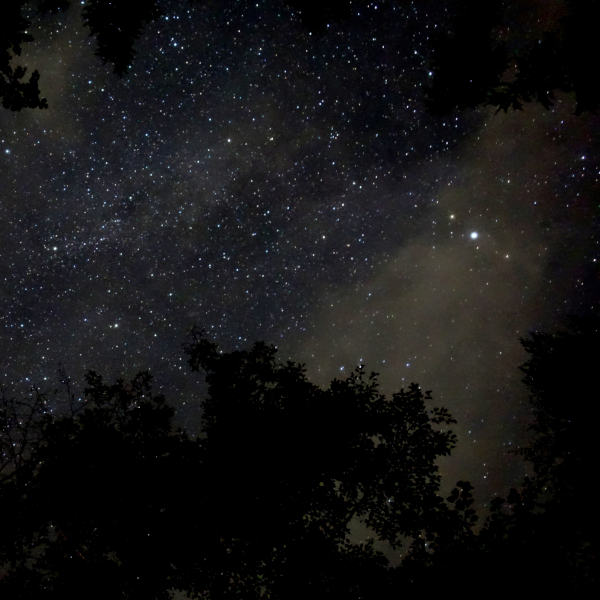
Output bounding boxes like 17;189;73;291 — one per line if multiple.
426;0;600;115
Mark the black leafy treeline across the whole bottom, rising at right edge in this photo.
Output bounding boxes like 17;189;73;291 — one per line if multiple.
0;318;600;600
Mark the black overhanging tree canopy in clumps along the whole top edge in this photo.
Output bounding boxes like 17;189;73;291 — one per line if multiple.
0;0;600;115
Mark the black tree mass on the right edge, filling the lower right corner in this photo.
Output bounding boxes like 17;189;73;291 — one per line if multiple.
414;315;600;597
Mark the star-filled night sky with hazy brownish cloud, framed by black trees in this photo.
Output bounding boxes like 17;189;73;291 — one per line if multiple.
0;0;600;528
